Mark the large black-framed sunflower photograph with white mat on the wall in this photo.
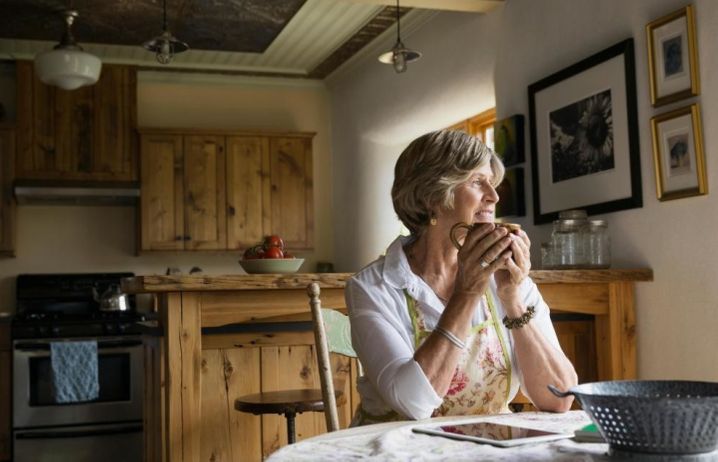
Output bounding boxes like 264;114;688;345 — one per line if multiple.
528;39;643;224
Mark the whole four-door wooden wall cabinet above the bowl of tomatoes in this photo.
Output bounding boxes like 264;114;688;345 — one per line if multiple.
140;129;314;251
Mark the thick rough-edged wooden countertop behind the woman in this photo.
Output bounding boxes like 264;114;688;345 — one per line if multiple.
122;268;653;293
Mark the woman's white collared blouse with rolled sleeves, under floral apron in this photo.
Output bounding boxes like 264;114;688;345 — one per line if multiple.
345;237;560;419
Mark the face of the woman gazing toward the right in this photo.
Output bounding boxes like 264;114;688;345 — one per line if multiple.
444;163;499;225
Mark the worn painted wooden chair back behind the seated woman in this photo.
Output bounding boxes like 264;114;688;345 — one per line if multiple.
307;282;357;432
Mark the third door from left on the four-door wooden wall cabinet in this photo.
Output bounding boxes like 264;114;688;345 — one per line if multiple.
227;136;269;250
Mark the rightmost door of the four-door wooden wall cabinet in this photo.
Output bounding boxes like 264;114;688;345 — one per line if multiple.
264;137;314;250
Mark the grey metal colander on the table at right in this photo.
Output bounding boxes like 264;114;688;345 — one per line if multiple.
549;380;718;454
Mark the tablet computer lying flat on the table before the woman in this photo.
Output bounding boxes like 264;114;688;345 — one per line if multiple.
413;422;573;448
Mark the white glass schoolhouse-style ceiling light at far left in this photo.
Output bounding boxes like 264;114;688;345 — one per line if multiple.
35;10;102;90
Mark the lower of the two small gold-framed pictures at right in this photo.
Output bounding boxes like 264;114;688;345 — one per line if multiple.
651;104;708;201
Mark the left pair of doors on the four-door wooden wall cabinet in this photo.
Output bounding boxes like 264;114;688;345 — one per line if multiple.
140;134;227;250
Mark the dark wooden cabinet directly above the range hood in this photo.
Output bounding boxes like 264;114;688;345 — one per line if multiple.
16;61;137;182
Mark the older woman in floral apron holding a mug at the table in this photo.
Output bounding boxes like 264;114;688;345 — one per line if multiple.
346;130;576;425
